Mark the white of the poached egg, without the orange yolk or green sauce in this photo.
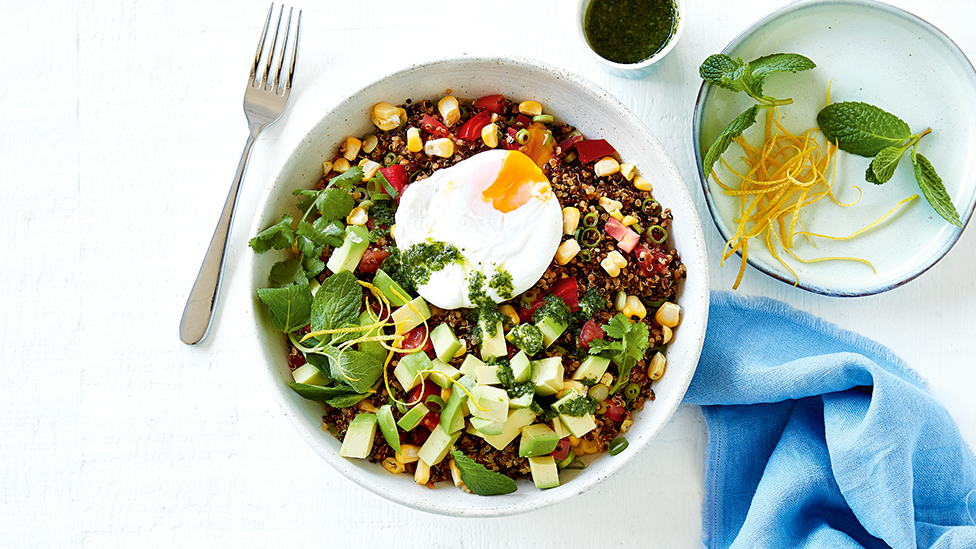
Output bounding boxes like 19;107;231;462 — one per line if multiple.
392;150;563;309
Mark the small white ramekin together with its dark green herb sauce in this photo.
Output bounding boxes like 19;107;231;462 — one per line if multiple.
576;0;685;78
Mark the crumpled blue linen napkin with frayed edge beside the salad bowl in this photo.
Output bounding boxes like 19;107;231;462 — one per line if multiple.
684;292;976;549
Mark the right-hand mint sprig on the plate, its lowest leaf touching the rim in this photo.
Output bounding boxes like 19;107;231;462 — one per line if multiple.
817;101;962;227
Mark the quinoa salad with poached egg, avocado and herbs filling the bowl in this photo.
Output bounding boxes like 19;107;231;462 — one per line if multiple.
250;91;686;496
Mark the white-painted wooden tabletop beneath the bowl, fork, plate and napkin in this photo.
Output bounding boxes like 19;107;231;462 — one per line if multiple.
0;0;976;549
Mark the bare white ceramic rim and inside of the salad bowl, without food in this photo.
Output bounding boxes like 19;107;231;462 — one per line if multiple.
246;57;708;516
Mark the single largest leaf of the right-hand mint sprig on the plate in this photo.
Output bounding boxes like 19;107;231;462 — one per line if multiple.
817;101;912;157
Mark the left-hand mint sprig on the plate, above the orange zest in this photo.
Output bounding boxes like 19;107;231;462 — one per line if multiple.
698;53;817;177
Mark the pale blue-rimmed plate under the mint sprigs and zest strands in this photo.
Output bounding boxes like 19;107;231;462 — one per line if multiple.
694;0;976;296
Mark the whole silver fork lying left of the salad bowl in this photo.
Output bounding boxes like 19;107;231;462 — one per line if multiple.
180;3;302;345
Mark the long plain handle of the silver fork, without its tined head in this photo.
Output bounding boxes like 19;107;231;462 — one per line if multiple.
180;128;260;345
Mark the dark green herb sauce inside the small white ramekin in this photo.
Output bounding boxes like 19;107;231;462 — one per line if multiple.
583;0;678;64
